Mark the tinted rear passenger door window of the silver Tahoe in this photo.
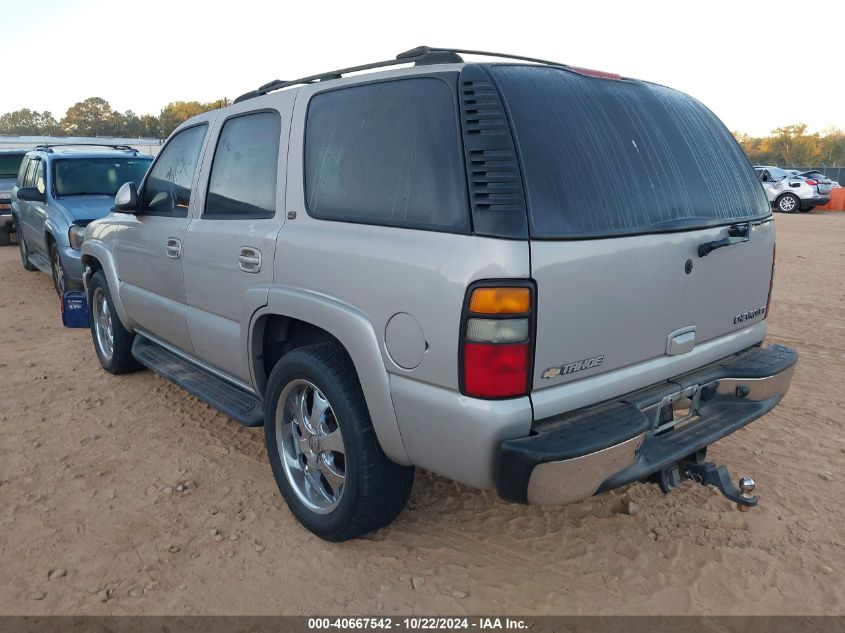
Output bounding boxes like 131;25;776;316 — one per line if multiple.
203;112;282;218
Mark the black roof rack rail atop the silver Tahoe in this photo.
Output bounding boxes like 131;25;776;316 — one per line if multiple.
234;46;568;103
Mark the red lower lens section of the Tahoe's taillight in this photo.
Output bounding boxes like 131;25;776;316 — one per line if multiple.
464;343;529;398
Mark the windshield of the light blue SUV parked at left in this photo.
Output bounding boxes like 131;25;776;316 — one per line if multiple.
53;156;152;197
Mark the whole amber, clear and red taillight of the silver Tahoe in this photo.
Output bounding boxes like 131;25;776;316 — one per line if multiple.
460;281;536;398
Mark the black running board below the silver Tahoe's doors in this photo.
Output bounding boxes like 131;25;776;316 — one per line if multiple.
132;334;264;426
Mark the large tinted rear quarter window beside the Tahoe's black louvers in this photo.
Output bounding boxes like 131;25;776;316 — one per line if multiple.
305;78;470;232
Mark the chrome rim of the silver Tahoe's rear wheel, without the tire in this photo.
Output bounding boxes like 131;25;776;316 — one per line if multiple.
275;379;346;514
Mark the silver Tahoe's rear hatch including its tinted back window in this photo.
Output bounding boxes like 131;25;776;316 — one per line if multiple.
491;65;774;400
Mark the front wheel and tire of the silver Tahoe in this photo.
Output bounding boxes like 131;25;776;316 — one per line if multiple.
88;270;141;374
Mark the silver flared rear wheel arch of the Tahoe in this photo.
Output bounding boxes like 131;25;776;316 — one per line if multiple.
244;287;411;466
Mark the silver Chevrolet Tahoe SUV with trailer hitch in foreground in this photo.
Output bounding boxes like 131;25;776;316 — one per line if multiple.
82;47;797;540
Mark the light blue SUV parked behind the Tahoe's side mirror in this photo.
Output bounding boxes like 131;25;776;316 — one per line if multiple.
12;145;152;295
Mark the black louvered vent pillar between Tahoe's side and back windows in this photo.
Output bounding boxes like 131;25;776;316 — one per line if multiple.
458;65;528;238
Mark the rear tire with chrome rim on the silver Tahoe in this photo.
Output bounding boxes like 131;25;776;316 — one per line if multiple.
264;343;414;542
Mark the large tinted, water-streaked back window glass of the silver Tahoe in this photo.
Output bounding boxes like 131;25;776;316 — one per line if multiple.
492;65;769;238
